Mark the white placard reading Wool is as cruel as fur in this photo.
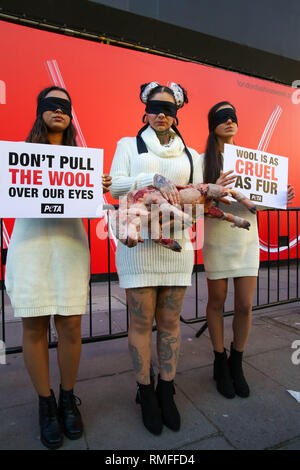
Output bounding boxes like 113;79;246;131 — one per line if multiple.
223;144;288;209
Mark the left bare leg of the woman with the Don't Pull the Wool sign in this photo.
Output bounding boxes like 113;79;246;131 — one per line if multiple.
22;316;50;397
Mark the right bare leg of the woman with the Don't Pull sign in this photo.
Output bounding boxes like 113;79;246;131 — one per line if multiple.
54;315;81;391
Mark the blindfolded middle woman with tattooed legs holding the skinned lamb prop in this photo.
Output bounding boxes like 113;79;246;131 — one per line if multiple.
111;82;202;434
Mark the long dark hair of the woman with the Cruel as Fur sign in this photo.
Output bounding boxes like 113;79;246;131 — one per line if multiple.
203;101;236;183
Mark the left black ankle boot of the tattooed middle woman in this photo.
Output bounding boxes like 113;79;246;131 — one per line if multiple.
136;382;163;435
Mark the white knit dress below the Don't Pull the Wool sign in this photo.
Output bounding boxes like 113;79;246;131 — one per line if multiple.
5;218;90;317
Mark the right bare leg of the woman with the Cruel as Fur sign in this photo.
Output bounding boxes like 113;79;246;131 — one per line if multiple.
232;276;256;352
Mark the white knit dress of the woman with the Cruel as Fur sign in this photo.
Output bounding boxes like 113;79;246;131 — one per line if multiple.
202;154;259;280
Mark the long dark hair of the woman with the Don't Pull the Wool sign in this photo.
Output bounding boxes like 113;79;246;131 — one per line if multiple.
26;86;77;146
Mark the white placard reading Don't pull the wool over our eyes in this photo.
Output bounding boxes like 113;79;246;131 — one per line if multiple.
0;141;103;218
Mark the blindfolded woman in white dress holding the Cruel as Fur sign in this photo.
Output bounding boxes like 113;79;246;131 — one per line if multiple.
202;101;294;398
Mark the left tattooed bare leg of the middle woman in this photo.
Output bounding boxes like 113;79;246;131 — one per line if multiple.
126;287;157;385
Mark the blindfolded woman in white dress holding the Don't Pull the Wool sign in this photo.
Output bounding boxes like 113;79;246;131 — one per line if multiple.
5;87;110;449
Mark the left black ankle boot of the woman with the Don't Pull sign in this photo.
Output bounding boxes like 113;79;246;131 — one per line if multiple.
39;390;63;449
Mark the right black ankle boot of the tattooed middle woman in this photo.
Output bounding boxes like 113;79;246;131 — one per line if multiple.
156;376;180;431
